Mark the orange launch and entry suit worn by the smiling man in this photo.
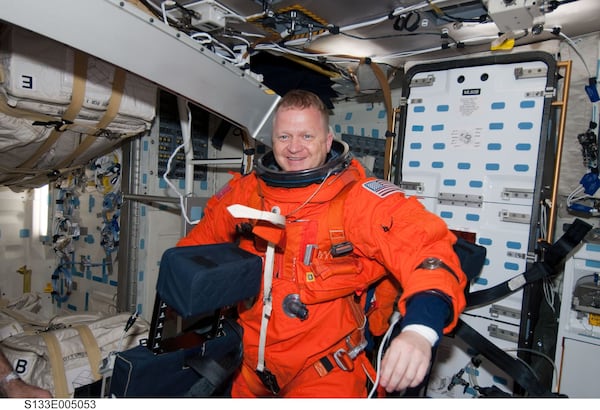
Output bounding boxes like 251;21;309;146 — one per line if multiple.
177;155;466;397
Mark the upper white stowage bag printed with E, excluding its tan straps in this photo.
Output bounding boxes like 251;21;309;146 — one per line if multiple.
0;26;157;133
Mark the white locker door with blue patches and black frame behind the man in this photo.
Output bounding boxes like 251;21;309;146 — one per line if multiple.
395;52;556;397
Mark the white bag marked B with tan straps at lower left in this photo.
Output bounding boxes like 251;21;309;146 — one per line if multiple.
0;309;149;398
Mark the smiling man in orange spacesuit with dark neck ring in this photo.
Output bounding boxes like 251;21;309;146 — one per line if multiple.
177;90;466;398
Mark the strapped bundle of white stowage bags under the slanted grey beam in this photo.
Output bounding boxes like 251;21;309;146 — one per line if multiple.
0;23;158;192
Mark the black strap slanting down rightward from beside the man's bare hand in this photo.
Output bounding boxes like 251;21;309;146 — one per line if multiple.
454;319;555;397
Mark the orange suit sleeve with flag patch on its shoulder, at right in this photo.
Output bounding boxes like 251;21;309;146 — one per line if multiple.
344;180;467;333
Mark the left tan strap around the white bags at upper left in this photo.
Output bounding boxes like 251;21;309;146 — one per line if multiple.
17;51;88;168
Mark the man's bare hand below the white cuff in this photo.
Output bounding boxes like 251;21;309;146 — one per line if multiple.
380;330;431;393
